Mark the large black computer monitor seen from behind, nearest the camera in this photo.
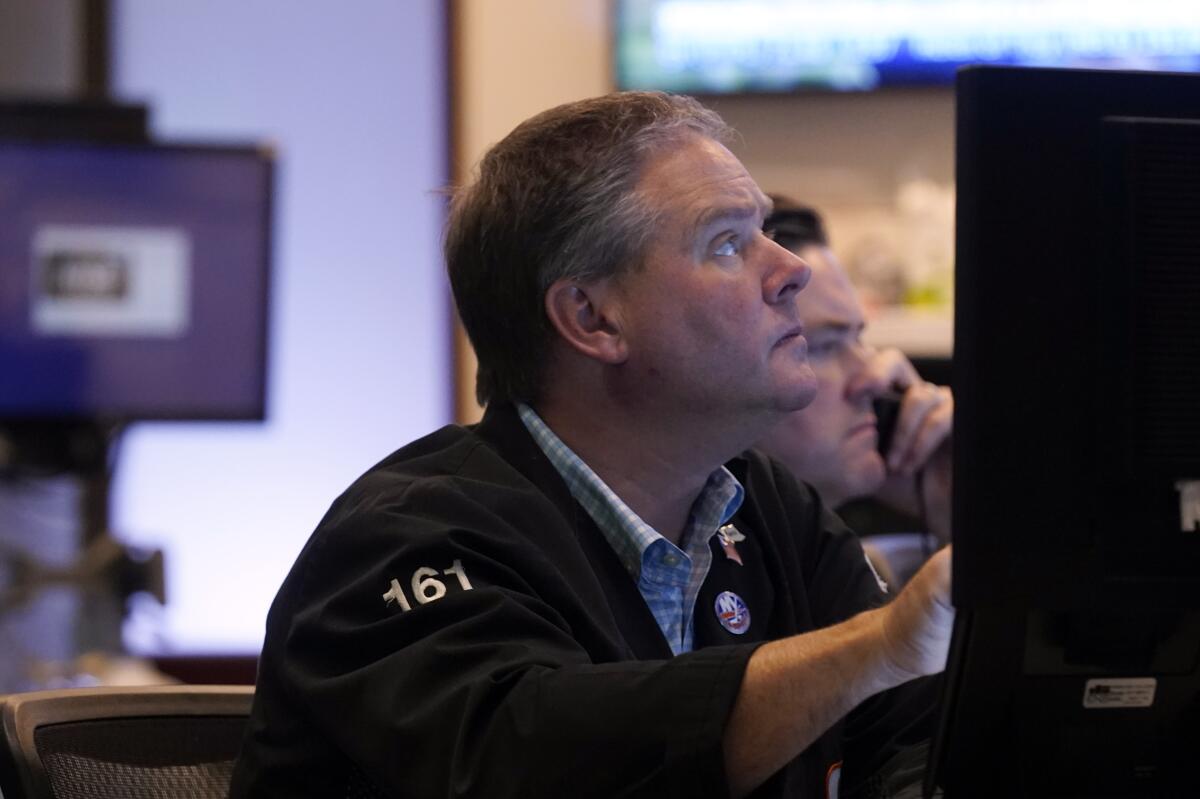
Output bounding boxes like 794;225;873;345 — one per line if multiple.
926;67;1200;797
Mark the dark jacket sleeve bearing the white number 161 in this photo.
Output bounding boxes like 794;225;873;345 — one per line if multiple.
277;472;754;799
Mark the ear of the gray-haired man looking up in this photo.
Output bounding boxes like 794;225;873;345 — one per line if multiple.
546;280;628;365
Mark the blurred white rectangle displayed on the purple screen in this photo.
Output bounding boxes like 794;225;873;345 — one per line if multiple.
30;224;192;338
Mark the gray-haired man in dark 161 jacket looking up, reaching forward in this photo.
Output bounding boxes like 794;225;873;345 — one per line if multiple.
233;94;953;797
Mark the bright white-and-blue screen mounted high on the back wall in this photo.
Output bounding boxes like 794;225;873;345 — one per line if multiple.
613;0;1200;94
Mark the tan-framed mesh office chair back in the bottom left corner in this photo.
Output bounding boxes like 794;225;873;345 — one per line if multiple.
0;685;254;799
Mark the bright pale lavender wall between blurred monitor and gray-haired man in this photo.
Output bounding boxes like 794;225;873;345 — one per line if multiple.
113;0;451;651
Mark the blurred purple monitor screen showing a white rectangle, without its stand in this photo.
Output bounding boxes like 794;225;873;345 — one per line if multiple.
0;139;272;421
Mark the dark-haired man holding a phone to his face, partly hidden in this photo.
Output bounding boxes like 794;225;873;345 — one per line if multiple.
758;196;954;568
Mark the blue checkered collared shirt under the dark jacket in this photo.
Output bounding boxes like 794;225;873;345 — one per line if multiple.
517;404;745;655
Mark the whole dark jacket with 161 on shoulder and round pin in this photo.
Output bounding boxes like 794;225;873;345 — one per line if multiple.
233;408;931;799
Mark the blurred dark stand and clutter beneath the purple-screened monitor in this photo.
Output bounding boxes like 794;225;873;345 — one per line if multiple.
0;421;164;690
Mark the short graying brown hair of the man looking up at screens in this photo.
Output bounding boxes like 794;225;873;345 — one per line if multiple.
445;92;733;404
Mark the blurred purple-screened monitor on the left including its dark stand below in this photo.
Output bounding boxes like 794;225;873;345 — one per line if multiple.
0;131;274;690
